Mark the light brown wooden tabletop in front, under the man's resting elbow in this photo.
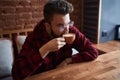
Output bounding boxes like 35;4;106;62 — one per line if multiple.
25;50;120;80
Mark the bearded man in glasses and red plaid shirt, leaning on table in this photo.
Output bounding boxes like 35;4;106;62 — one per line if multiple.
12;0;98;80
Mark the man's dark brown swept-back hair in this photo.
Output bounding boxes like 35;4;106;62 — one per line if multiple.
43;0;73;23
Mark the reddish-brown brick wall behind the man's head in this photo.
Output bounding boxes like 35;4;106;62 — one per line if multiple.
0;0;81;31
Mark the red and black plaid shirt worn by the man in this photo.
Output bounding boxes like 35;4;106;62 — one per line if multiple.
12;20;98;80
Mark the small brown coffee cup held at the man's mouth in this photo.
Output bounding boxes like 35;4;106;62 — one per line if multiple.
63;33;75;44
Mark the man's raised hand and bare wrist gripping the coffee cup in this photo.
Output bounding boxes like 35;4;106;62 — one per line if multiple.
40;37;66;56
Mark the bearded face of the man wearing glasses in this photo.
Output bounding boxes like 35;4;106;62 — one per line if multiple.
50;14;70;37
